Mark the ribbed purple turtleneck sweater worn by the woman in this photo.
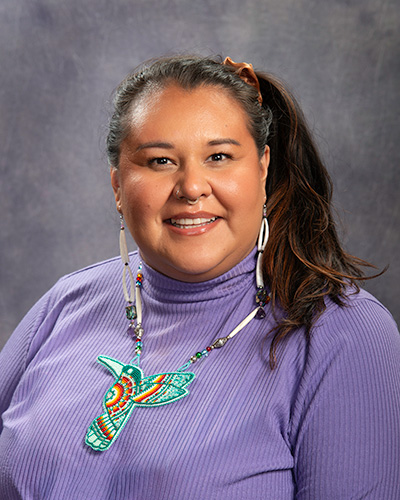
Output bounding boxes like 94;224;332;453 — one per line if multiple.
0;252;400;500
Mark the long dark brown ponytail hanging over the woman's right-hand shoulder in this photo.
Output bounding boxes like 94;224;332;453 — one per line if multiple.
257;73;374;365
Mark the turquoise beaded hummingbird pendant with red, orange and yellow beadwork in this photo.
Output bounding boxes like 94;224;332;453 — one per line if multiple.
85;356;195;451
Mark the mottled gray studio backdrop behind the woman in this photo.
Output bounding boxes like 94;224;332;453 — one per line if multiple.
0;0;400;346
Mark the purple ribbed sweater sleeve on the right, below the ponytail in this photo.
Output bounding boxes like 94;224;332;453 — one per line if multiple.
293;299;400;500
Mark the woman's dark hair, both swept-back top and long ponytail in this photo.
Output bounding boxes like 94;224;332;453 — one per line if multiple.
107;56;373;366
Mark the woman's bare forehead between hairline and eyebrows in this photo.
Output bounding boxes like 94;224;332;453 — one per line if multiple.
128;84;248;139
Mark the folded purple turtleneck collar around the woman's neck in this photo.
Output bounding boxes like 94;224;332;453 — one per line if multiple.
142;248;257;303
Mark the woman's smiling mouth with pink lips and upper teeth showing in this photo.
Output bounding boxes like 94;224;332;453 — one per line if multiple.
164;212;221;236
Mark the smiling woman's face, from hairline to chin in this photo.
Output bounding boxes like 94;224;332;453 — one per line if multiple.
111;85;269;282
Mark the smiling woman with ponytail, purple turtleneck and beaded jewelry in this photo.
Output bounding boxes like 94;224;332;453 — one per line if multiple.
0;57;400;500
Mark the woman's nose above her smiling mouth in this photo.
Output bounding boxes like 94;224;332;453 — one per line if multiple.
174;161;212;201
